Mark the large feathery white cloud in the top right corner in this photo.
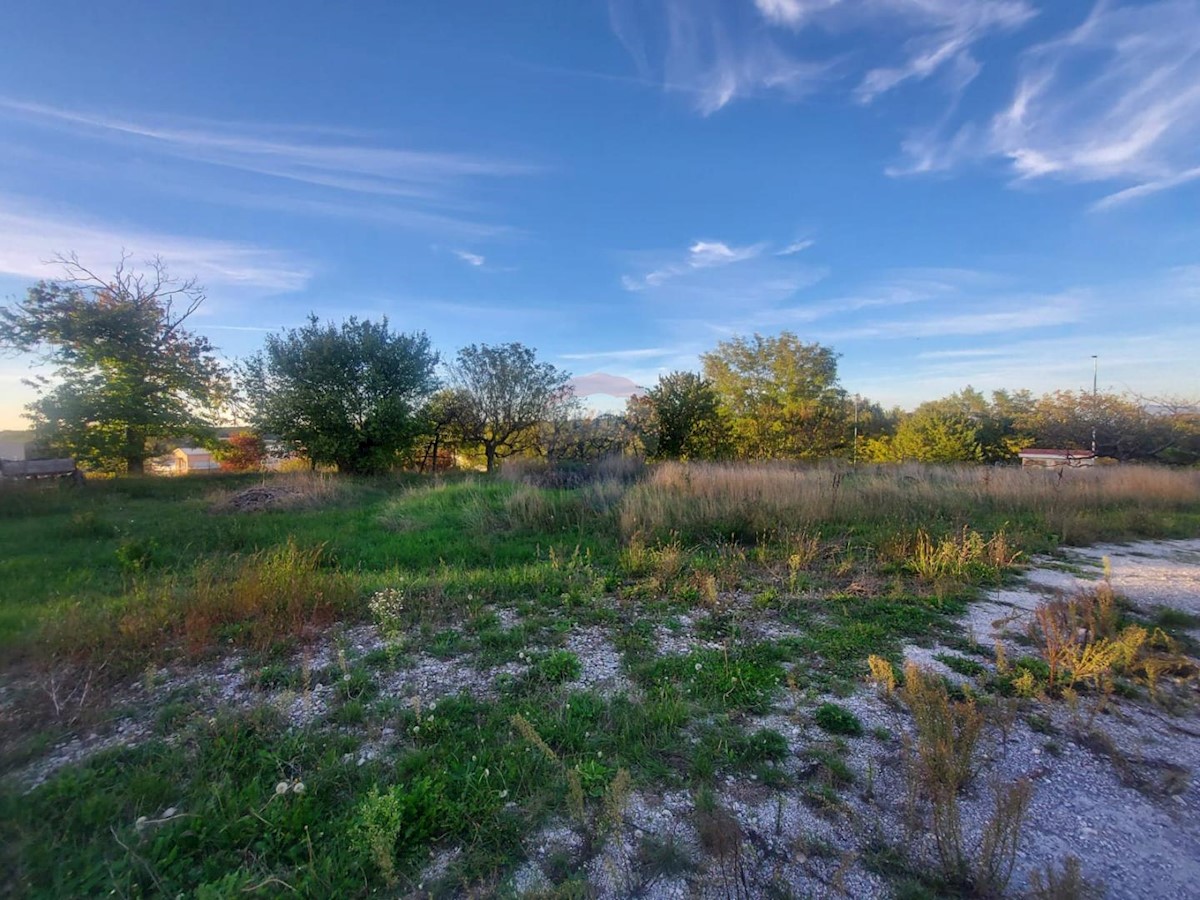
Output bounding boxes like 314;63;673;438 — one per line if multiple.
892;0;1200;210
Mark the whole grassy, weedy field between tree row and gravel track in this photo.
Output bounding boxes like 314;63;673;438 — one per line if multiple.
0;464;1200;898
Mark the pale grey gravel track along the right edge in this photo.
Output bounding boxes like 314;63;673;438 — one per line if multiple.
897;540;1200;898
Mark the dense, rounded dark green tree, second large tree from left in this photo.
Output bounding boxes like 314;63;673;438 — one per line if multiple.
241;316;438;474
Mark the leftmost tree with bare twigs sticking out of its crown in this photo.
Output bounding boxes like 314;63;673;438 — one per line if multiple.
0;254;229;474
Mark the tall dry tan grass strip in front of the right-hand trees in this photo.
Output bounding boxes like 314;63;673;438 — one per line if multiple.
620;463;1200;542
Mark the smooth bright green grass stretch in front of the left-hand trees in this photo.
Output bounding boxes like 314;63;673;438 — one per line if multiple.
0;475;616;654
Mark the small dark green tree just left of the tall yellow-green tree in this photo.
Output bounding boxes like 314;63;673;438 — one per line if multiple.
630;372;730;460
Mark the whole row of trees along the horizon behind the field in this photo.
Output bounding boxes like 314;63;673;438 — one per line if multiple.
0;257;1200;473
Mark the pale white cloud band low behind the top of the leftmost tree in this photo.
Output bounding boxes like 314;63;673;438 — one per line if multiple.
0;196;313;293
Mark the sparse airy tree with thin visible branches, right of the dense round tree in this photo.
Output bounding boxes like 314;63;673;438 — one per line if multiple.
450;343;575;472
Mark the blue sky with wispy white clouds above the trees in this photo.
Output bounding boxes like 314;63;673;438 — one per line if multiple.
0;0;1200;427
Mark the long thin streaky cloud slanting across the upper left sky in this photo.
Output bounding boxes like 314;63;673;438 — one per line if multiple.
0;96;541;236
